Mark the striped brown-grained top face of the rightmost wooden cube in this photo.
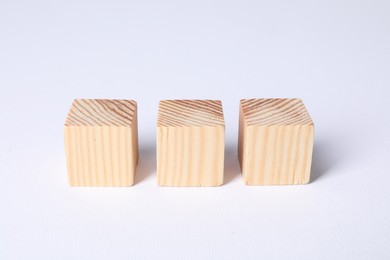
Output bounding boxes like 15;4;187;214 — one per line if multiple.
240;98;313;126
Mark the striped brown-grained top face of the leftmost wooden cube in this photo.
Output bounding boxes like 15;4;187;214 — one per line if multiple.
65;99;137;126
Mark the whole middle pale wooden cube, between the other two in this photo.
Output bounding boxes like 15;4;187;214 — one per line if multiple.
157;100;225;186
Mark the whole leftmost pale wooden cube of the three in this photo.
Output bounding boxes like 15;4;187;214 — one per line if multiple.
64;99;138;186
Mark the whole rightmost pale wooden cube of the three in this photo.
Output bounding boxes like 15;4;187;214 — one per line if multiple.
238;98;314;185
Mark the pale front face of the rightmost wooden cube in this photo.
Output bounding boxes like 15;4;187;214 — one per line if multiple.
243;125;314;185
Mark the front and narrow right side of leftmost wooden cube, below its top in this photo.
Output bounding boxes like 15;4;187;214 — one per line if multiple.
64;125;138;187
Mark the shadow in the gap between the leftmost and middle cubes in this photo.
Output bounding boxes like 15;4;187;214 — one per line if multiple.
134;142;157;184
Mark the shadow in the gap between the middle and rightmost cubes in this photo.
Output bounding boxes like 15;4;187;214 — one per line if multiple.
224;143;241;184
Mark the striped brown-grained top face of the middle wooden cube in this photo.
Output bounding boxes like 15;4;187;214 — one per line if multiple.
157;100;225;127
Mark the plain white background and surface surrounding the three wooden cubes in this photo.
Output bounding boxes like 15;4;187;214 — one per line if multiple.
0;0;390;260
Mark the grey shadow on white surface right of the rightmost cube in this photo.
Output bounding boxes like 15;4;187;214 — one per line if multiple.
310;141;339;182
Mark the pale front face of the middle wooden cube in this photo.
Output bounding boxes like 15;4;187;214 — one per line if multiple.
157;126;225;186
